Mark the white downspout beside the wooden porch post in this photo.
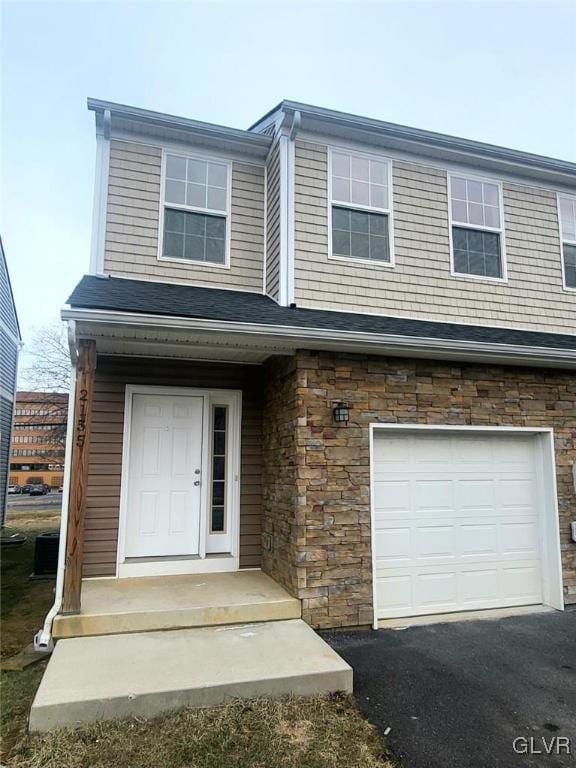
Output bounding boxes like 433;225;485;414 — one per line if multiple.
34;320;76;653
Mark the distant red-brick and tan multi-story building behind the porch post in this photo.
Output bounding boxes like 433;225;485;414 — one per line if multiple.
10;392;68;489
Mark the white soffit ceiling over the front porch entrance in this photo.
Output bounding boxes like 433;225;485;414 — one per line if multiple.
76;322;294;364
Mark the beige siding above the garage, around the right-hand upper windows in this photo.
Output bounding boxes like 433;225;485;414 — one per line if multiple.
295;142;576;333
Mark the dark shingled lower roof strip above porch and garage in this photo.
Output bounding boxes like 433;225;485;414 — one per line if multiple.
68;275;576;351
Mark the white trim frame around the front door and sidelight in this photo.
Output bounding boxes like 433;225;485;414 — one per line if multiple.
116;384;242;578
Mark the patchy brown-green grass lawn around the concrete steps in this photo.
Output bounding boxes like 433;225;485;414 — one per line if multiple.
0;510;392;768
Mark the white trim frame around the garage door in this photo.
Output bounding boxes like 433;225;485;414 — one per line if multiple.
369;422;564;629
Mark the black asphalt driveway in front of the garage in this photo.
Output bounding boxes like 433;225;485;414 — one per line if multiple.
323;610;576;768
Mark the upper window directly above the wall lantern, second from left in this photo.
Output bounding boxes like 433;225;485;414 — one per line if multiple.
330;150;392;264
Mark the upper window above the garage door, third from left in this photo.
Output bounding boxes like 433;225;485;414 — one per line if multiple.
450;176;506;280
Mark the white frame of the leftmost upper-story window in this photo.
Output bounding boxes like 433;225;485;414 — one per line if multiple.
157;148;232;269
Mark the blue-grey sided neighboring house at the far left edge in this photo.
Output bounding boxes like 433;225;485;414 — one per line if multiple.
0;238;22;525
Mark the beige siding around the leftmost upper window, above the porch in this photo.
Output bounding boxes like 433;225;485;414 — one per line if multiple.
104;141;264;293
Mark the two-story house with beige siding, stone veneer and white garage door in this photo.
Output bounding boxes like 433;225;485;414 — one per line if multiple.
56;100;576;627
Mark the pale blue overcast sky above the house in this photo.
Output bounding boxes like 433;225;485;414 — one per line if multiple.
0;0;576;372
